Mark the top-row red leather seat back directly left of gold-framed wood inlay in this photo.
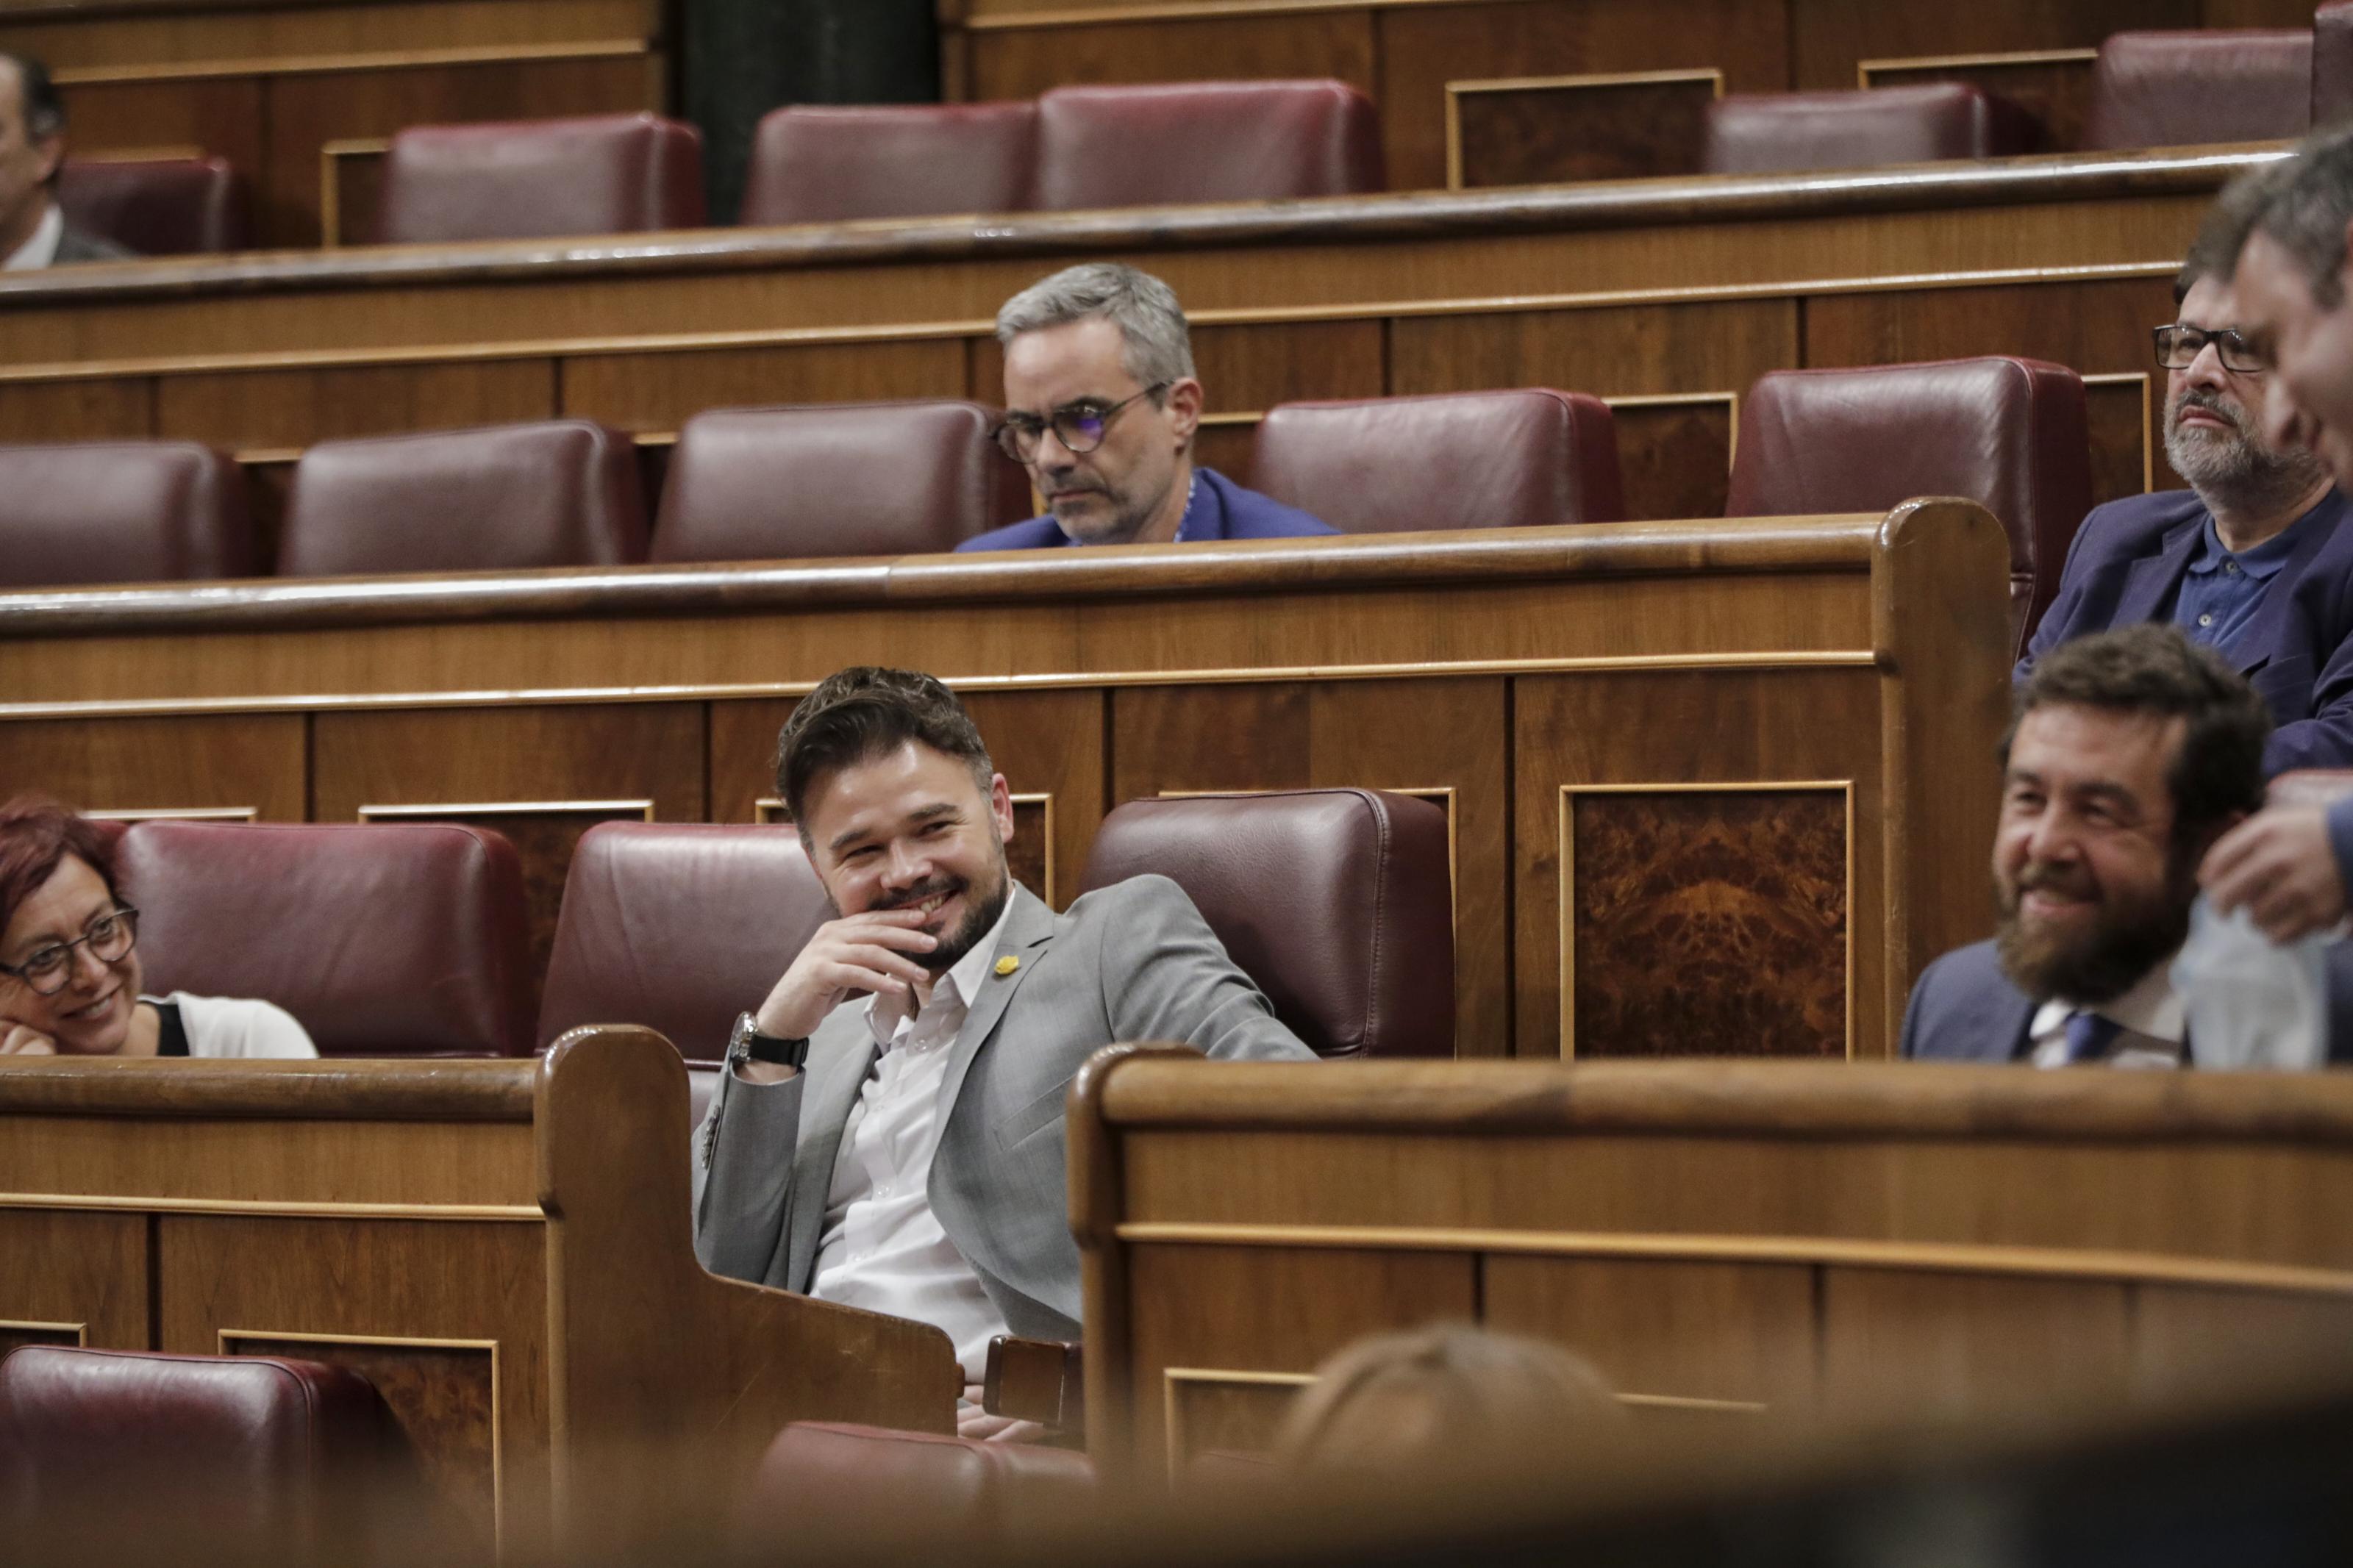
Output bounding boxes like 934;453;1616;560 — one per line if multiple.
1035;80;1381;212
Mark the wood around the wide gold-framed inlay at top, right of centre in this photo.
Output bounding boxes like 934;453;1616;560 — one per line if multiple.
1374;0;1779;190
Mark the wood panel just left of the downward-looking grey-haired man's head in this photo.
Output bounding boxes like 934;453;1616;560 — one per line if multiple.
560;338;969;430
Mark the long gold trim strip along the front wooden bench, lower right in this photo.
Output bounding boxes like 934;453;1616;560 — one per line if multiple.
1113;1222;2353;1295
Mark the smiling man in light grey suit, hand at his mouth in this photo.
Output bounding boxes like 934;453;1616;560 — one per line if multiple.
694;667;1313;1436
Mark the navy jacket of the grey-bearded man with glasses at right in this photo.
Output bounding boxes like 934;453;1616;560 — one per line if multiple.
2014;489;2353;778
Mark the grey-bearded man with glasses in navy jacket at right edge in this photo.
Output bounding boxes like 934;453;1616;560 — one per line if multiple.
2016;217;2353;778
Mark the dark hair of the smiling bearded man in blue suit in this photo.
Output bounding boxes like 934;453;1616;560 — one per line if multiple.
2000;620;2271;848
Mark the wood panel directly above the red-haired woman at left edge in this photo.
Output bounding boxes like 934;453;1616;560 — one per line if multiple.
0;715;304;823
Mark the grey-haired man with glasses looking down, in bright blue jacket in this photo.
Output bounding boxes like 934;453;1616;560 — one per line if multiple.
957;261;1337;550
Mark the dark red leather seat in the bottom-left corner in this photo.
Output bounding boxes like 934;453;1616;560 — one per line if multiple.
0;1345;414;1561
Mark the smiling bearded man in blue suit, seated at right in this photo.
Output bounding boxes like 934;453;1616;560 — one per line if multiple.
1904;626;2271;1067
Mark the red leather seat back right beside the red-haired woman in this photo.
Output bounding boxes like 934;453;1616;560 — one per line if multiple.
118;823;532;1056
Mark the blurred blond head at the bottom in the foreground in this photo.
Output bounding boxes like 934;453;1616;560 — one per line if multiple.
1275;1323;1626;1476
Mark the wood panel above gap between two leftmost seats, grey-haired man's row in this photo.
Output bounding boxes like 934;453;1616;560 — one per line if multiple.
155;359;555;449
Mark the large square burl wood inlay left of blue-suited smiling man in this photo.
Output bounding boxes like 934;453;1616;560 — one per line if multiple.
1563;785;1847;1056
